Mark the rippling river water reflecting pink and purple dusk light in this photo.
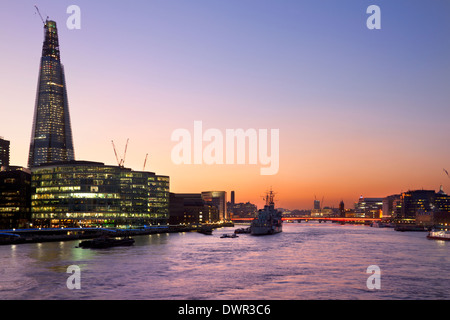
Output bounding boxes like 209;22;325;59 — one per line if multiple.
0;223;450;300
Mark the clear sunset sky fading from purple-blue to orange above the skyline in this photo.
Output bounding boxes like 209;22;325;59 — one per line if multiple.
0;0;450;209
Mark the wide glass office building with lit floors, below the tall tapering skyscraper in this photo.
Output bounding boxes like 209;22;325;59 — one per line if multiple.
31;161;169;228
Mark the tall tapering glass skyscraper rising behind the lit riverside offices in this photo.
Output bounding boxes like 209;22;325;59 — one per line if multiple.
28;20;75;168
